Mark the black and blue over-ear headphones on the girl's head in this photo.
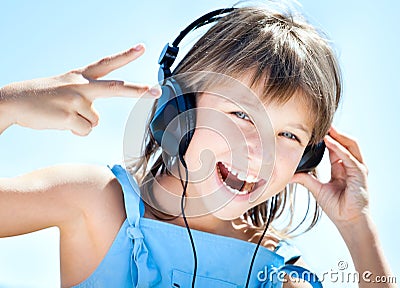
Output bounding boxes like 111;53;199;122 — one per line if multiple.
150;8;325;173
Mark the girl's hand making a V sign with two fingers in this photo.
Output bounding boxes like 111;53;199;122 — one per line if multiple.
0;44;161;136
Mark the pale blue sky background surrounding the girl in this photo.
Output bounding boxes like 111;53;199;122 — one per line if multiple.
0;0;400;287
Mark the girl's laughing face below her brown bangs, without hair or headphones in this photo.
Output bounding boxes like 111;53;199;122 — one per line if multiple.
185;77;312;220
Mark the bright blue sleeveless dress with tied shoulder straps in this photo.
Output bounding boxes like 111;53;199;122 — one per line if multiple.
74;165;322;288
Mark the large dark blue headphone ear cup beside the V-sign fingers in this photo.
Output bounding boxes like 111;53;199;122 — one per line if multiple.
150;78;196;156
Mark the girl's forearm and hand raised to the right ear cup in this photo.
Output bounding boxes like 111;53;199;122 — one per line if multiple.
293;128;396;287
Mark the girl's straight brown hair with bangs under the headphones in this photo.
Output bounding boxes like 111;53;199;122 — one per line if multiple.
130;7;341;236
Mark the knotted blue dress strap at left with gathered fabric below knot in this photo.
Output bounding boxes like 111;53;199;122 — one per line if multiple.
111;165;161;287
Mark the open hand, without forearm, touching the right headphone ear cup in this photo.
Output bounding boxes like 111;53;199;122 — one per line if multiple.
292;128;368;230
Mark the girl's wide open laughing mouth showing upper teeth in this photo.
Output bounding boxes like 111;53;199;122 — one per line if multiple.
217;162;258;195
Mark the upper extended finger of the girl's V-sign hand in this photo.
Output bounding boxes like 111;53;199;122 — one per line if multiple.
82;44;145;79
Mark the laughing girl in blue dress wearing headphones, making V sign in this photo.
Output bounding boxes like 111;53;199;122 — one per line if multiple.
0;7;390;287
